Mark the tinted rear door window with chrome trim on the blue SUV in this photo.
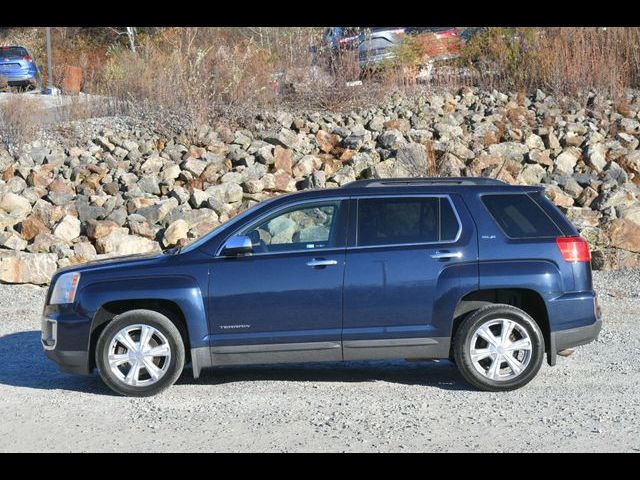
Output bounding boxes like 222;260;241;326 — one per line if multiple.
357;197;459;246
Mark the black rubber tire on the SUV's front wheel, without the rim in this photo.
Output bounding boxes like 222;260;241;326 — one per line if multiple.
96;310;185;397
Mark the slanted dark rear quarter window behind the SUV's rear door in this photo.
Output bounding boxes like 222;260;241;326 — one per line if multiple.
482;194;562;238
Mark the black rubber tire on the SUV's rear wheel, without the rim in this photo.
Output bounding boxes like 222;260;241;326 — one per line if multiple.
453;304;545;392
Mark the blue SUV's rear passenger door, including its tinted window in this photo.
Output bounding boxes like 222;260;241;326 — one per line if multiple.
342;195;478;360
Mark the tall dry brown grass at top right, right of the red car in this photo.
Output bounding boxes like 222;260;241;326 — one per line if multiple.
461;27;640;96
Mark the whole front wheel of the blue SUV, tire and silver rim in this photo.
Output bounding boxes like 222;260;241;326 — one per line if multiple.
96;310;185;397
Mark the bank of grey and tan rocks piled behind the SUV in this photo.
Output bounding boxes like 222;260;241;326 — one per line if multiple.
0;88;640;284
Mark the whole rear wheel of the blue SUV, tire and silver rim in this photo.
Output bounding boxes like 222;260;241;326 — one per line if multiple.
453;305;544;392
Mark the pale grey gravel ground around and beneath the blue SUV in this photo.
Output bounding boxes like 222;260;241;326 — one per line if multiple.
0;270;640;452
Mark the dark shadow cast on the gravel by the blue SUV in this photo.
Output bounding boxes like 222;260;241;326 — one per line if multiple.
0;330;473;395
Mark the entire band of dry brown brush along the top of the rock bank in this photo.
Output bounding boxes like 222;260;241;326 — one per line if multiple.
0;27;640;137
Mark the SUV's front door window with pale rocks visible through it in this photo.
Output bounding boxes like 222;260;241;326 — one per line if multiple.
240;201;341;253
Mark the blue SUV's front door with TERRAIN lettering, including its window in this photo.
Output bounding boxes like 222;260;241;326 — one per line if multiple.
209;200;346;364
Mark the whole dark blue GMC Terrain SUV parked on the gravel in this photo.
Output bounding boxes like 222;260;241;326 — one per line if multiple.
42;178;601;396
